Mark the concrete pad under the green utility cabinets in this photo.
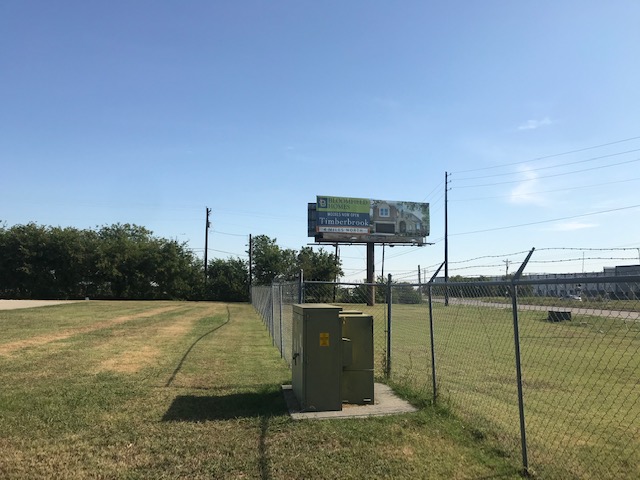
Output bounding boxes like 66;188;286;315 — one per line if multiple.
282;383;418;420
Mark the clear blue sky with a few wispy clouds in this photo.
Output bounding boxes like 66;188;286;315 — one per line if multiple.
0;0;640;281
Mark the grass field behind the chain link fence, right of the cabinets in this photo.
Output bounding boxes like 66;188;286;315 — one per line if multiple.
328;299;640;479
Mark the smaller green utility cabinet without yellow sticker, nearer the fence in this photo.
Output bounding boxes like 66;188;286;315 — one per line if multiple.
340;311;374;404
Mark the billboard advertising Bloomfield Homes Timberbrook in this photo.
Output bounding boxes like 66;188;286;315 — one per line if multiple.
308;195;429;245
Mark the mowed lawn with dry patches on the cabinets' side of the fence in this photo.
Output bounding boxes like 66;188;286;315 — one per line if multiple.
0;301;519;479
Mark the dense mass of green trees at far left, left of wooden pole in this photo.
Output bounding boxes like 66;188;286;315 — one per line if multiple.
0;223;202;299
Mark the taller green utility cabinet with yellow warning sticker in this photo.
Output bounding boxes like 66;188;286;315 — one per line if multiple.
291;303;343;411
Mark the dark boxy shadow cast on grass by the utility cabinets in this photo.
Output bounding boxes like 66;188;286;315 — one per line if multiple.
162;388;287;422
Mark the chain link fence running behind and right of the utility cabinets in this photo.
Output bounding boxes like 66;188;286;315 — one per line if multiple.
252;276;640;479
